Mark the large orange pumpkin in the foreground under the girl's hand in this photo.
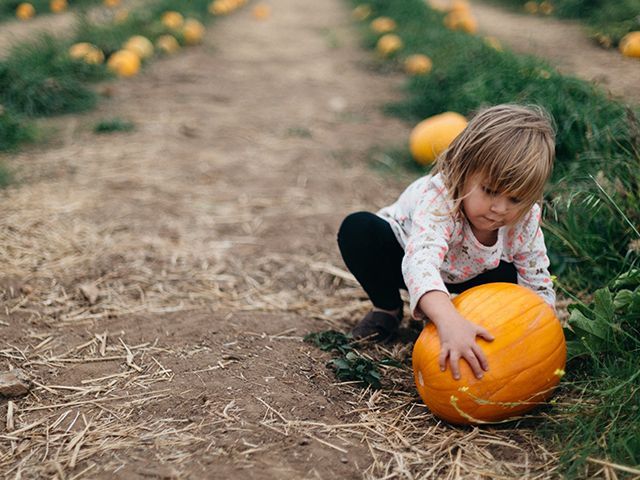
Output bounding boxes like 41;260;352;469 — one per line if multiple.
413;283;567;424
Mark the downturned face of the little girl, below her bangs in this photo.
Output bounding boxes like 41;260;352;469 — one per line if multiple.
462;175;522;233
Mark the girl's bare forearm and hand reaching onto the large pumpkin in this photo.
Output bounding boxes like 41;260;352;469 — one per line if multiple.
418;290;493;380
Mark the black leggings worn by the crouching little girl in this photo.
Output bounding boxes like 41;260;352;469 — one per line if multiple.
338;212;518;310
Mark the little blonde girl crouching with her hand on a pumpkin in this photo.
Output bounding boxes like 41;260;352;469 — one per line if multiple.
338;105;555;379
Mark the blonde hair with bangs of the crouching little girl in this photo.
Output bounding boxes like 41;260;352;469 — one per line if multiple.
434;104;555;220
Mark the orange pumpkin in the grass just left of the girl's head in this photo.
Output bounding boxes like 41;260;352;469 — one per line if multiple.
409;112;467;165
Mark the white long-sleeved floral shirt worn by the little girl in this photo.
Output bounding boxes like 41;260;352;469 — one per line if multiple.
377;174;555;318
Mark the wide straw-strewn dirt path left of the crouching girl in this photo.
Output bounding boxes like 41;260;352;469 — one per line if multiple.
0;0;555;479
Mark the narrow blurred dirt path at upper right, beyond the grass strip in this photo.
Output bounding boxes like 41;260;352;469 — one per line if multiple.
472;1;640;104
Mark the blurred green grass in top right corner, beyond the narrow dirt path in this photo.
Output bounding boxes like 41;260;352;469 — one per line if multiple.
484;0;640;48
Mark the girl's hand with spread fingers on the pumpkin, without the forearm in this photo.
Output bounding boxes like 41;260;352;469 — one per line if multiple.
437;312;493;380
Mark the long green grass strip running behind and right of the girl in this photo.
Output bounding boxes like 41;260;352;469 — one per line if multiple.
353;0;640;477
